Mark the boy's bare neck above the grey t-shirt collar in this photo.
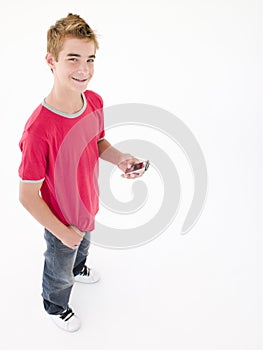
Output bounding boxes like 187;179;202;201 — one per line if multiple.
45;87;83;114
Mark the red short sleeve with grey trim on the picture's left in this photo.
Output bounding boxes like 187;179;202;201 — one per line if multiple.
18;131;48;182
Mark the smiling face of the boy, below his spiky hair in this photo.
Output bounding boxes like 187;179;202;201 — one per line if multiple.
46;38;95;92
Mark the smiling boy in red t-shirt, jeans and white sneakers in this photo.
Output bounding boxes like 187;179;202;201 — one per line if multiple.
19;14;144;332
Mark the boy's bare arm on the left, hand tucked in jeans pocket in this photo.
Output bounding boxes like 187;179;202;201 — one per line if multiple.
19;182;82;249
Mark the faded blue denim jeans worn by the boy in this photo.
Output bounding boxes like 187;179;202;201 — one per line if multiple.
42;229;90;315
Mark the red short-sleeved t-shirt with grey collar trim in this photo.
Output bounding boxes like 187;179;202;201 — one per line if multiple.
19;90;104;231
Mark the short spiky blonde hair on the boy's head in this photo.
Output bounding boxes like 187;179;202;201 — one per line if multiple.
47;13;99;60
